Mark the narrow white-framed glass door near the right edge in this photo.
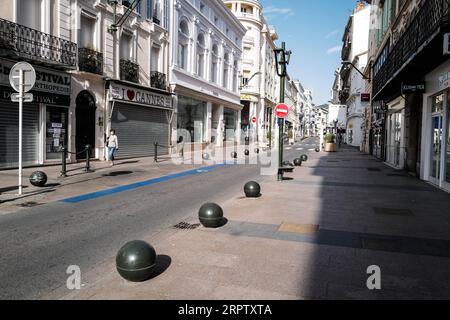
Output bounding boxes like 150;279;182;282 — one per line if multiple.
430;94;444;185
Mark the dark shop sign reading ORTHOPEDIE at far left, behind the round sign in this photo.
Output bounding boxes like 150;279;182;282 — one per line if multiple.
0;60;71;106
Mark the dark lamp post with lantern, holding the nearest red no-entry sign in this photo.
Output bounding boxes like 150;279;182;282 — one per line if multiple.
274;42;292;180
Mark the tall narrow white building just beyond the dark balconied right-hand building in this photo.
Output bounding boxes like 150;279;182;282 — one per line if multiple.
341;1;370;148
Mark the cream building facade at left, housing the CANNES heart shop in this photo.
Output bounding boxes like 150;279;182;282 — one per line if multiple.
0;0;173;168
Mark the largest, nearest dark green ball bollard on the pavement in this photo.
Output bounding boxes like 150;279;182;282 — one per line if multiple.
116;240;156;282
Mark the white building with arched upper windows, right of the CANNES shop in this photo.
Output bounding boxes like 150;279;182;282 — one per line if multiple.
170;0;246;148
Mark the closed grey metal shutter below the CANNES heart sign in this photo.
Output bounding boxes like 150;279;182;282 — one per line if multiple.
111;103;170;159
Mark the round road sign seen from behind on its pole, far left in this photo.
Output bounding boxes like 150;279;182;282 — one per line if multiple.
9;62;36;195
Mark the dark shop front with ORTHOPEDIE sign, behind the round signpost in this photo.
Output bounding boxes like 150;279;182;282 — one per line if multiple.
0;59;71;169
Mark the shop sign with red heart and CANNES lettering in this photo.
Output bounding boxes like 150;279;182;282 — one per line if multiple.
110;83;172;109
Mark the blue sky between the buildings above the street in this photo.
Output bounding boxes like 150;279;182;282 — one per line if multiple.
260;0;356;104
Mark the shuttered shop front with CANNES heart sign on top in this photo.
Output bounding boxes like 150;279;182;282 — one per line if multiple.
106;81;173;159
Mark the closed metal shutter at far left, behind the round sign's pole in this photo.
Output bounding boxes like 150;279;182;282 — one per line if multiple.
0;102;39;169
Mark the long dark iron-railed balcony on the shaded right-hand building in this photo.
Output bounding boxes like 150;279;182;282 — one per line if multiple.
373;0;450;98
